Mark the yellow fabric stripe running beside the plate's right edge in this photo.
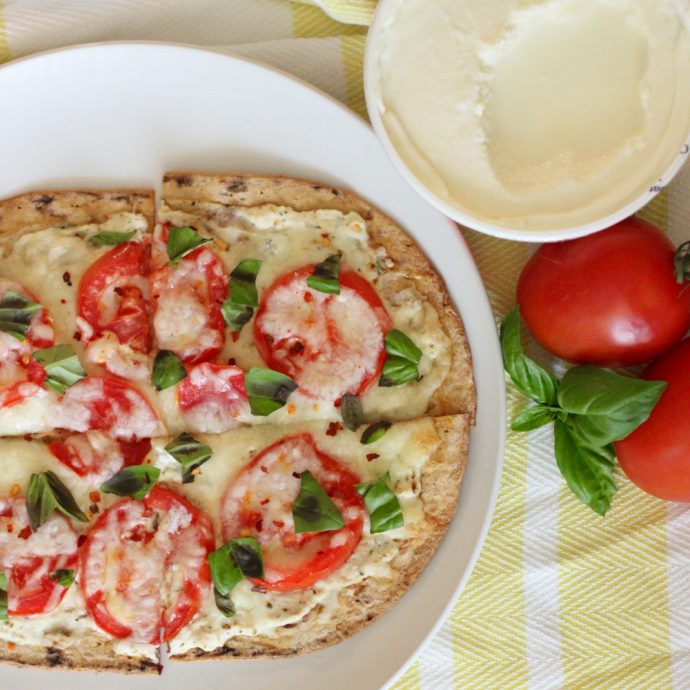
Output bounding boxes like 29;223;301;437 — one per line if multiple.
450;230;528;690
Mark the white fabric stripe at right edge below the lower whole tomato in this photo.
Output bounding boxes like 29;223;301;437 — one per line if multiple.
666;503;690;689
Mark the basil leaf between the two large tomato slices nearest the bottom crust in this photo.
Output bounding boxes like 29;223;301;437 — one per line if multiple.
208;537;264;616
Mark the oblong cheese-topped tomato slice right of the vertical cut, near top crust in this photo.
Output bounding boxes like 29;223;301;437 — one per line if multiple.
151;224;228;364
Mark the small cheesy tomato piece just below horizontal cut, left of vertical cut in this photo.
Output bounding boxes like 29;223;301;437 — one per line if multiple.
48;431;151;486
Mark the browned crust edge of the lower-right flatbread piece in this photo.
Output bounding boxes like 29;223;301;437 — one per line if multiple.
172;415;470;661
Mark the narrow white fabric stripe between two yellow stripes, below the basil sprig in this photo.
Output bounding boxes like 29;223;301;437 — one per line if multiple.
524;424;563;690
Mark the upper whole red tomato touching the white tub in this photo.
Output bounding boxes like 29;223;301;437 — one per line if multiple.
517;218;690;367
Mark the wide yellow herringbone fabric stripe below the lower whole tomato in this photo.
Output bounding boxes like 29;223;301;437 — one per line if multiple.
558;472;671;690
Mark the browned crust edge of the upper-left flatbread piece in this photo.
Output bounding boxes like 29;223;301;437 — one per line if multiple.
0;189;155;238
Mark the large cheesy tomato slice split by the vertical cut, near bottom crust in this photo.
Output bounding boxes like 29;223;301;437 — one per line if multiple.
80;486;215;644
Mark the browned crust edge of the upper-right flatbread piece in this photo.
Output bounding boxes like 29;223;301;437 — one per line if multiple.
163;172;476;420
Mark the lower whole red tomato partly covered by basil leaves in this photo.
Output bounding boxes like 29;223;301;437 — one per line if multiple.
614;338;690;501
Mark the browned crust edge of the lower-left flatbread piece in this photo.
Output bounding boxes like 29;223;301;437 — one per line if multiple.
0;636;161;673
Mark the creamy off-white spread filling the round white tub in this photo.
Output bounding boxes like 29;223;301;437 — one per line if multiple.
374;0;690;230
